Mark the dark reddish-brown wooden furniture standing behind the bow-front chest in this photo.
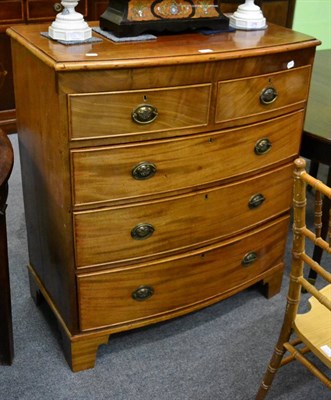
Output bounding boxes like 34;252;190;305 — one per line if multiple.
0;0;295;133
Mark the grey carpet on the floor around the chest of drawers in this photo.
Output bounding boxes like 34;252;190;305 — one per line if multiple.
0;135;331;400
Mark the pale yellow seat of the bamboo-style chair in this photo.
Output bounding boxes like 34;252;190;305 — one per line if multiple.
293;284;331;369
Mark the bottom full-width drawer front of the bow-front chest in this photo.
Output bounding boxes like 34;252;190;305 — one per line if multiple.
78;217;288;330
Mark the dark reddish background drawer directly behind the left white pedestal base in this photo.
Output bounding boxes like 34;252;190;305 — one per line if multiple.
26;0;87;21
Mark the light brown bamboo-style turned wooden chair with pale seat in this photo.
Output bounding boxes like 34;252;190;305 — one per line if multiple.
256;158;331;400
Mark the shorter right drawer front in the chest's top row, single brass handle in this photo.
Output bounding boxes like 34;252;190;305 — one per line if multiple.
215;66;311;126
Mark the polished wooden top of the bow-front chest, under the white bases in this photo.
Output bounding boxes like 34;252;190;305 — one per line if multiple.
7;23;319;71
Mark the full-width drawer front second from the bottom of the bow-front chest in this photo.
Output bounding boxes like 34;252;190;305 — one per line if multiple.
74;164;292;268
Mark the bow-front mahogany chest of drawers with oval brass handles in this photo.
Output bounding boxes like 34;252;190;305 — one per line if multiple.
9;25;319;371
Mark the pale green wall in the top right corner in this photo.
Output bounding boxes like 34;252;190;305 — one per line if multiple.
293;0;331;50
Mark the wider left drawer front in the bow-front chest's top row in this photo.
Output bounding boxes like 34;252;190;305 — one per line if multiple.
69;84;211;139
